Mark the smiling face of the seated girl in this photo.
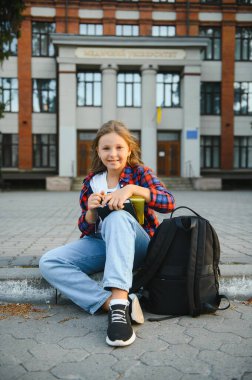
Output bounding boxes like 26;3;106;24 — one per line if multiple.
97;132;131;173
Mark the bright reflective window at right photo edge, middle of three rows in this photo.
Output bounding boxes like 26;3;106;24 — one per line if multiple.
234;82;252;115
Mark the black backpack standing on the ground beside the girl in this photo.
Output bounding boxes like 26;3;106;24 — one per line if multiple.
130;206;230;320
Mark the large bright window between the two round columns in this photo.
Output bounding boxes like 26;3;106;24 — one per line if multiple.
117;72;141;107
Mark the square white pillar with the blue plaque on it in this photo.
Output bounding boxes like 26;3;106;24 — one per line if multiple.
181;66;200;177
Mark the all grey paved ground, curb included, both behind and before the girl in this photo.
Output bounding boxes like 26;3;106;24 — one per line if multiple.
0;192;252;380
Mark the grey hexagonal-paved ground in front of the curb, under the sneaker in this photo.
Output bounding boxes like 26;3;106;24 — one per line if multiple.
0;301;252;380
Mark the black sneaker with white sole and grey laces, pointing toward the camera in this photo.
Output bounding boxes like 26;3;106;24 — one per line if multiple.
106;304;136;346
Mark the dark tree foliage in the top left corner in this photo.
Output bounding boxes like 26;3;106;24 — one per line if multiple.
0;0;25;119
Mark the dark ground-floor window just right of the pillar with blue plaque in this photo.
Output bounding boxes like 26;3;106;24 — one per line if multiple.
200;136;220;169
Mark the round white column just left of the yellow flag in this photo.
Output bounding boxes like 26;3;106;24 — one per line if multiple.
141;64;157;172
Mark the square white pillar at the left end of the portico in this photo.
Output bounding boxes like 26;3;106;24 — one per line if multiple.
59;64;77;177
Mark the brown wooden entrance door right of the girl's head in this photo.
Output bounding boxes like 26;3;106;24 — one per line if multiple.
157;132;180;177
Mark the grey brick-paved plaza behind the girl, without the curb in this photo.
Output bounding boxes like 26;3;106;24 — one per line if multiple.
0;191;252;267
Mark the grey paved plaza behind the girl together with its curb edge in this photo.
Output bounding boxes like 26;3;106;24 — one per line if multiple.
0;191;252;303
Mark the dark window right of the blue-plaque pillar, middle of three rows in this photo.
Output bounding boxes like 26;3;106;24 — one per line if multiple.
200;82;221;115
